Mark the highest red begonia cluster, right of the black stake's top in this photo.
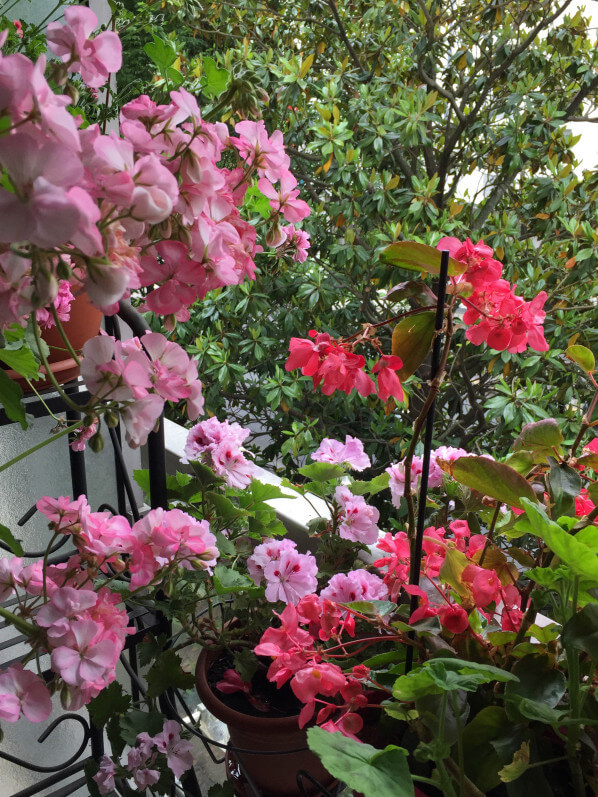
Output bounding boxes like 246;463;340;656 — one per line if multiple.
437;233;548;353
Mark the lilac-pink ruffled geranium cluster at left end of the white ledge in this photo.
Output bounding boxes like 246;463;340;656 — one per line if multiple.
181;417;255;489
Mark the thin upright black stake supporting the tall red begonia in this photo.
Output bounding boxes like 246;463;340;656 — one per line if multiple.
405;249;449;673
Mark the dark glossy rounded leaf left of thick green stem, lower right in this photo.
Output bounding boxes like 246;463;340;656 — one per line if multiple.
505;654;567;722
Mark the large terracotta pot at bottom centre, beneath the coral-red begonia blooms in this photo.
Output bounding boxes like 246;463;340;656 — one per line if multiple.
195;650;335;797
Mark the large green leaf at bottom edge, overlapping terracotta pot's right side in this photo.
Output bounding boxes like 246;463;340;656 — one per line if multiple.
307;728;414;797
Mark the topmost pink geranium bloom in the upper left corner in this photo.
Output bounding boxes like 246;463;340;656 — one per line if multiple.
46;5;122;88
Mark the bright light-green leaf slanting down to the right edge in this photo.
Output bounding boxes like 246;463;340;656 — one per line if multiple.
515;498;598;581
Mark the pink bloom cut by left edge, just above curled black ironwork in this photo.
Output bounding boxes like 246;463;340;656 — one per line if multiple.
0;664;52;722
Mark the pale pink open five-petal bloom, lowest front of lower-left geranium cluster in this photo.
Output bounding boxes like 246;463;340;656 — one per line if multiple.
51;620;120;686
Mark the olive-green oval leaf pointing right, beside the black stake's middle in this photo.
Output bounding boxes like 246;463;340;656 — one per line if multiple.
449;457;536;509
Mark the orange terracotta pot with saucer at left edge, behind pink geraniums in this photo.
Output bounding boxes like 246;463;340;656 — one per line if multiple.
7;292;102;394
